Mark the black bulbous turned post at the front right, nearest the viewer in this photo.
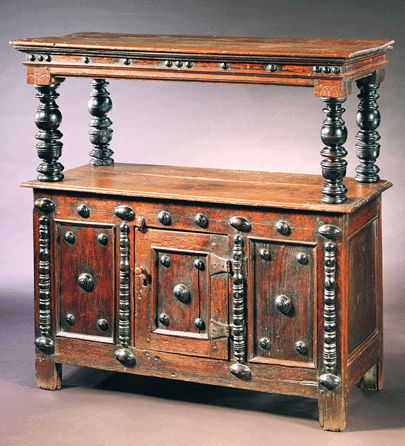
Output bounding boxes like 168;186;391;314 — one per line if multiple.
321;97;347;204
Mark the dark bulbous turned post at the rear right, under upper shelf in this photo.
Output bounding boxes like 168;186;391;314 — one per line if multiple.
355;77;381;183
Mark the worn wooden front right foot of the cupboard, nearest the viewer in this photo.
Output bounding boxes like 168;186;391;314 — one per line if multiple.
318;389;347;432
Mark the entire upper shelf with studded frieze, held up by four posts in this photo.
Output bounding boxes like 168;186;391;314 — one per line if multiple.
10;33;394;98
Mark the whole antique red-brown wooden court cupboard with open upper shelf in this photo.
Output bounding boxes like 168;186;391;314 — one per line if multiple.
15;33;393;431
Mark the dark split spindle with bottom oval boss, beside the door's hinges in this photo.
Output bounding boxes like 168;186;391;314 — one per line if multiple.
229;235;250;379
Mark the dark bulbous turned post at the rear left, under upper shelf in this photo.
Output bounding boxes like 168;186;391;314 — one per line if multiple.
88;79;114;166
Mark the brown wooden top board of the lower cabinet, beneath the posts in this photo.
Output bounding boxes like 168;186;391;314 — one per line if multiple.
21;163;392;213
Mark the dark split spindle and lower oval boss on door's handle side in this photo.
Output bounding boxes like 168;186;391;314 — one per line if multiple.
114;222;135;367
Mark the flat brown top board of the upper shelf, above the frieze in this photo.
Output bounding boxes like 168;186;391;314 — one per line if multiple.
10;33;394;59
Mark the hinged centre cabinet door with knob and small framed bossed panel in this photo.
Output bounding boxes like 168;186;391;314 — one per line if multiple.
135;229;230;359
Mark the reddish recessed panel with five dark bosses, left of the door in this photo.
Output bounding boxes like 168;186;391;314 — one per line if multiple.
57;223;115;342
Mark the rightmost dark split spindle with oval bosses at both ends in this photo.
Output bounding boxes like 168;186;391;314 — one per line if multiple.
318;225;341;390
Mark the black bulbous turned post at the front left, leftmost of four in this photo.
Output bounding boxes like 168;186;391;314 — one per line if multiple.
35;79;64;182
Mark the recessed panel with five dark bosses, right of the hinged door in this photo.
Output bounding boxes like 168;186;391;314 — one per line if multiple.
249;240;316;366
